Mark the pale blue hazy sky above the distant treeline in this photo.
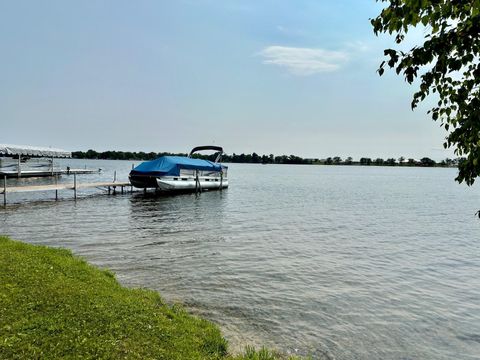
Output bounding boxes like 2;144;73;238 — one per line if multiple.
0;0;453;160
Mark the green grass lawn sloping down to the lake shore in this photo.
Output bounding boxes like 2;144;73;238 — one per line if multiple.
0;237;296;360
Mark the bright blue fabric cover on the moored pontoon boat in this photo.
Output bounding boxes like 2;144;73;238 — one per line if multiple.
130;156;222;176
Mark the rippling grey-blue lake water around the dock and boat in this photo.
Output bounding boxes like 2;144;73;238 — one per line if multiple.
0;160;480;359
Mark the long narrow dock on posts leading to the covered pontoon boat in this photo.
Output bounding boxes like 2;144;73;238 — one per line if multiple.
0;173;133;206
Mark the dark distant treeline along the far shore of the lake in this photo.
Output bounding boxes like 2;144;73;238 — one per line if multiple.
72;150;464;167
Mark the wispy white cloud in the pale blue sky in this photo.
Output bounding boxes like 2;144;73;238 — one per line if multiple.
259;46;348;76
